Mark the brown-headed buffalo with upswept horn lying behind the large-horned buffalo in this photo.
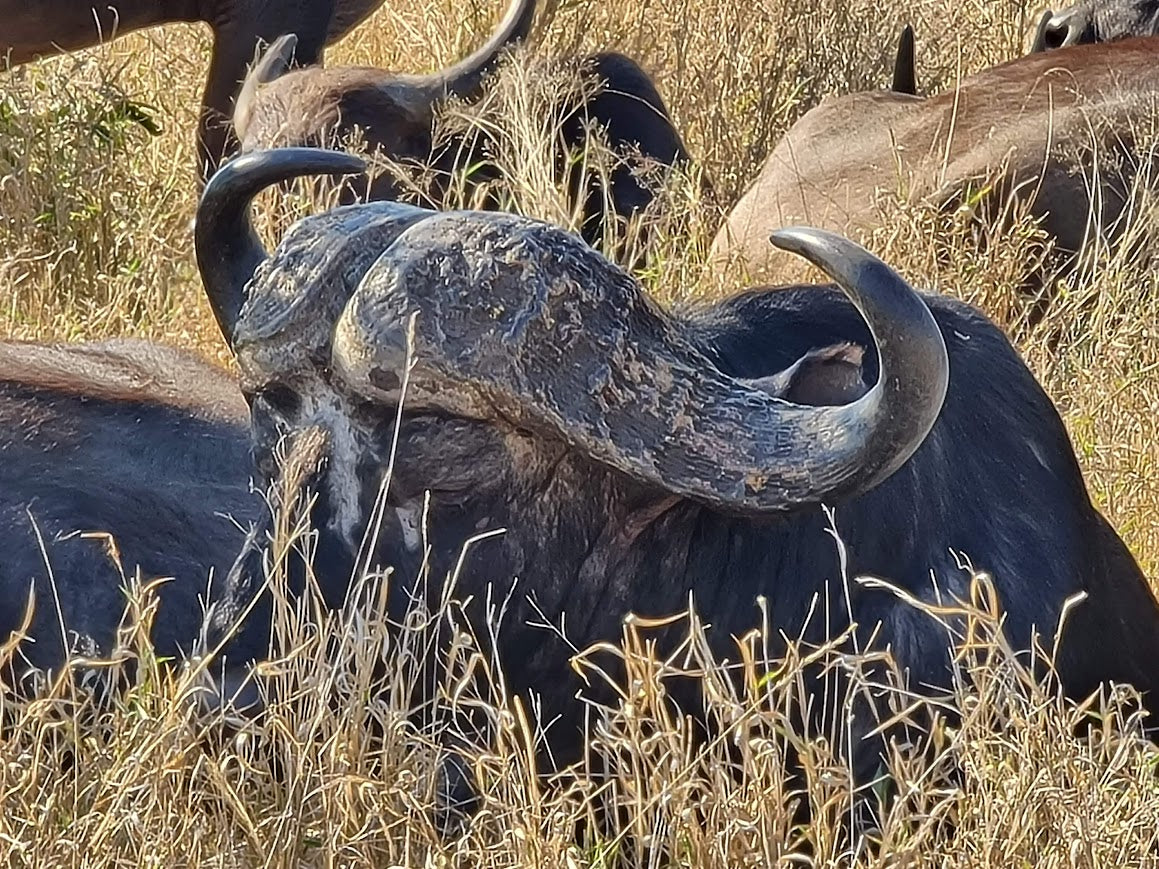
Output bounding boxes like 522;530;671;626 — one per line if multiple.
234;0;690;265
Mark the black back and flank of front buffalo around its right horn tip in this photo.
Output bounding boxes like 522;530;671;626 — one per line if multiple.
693;290;1159;723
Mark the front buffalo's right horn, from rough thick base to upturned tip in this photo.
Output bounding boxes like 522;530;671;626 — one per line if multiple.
333;212;948;512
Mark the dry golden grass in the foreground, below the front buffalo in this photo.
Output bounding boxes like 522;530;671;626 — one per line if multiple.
0;535;1159;868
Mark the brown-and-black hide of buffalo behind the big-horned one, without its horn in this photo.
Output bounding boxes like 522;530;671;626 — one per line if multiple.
236;46;691;254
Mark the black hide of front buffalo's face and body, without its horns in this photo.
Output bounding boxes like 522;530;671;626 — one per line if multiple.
376;294;1159;781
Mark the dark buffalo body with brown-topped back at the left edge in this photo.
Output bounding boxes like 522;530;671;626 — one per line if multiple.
0;341;258;679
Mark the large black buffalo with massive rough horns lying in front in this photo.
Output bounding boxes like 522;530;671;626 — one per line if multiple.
196;149;1159;774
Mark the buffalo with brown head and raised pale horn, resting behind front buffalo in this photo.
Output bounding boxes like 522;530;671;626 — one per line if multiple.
234;0;690;258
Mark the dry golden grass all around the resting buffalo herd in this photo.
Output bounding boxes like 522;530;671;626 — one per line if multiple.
0;0;1159;867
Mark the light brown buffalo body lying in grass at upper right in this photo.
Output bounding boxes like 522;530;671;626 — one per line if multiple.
713;38;1159;289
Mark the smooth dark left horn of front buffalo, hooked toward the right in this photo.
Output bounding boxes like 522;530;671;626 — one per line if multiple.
194;148;366;345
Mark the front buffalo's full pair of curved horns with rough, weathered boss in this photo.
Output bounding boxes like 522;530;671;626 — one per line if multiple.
197;148;946;512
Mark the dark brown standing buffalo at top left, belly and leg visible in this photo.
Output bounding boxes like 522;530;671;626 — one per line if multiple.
0;0;382;178
